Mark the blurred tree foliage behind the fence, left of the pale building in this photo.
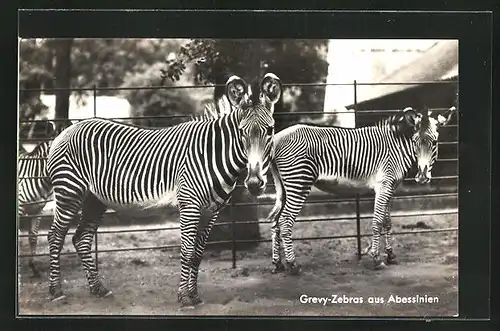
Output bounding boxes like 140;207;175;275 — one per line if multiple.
20;39;327;134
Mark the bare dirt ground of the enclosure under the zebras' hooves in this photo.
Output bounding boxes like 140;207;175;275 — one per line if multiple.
18;214;458;317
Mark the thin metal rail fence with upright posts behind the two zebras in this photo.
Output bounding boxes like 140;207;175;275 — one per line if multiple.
18;81;458;268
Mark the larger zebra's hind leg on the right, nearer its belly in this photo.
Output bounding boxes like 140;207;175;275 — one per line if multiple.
73;194;111;297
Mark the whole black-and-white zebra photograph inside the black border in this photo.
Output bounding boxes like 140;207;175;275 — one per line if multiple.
16;38;460;317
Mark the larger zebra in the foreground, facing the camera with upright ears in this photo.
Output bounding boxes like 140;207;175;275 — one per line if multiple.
47;73;282;307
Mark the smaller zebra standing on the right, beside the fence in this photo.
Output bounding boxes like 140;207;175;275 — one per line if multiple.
267;107;455;275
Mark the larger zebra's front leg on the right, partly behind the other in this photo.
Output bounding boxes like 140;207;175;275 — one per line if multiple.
188;211;219;305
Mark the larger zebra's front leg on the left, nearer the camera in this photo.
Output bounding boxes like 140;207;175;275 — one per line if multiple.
177;205;201;307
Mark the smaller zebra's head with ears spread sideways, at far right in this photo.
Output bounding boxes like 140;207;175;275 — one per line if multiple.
404;107;456;184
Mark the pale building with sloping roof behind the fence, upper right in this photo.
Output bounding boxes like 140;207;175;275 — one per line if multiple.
324;39;458;127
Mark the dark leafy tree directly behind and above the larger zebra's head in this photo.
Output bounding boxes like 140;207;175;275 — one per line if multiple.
163;39;328;131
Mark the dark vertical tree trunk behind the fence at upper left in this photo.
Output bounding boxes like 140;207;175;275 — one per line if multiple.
54;39;73;131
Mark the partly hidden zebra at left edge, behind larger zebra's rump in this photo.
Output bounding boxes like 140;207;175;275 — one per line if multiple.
17;121;69;277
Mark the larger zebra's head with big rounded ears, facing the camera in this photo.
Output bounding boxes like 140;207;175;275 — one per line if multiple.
226;73;282;196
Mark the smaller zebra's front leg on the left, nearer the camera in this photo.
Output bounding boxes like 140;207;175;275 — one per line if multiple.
369;184;394;270
